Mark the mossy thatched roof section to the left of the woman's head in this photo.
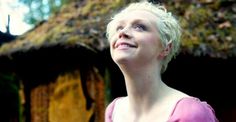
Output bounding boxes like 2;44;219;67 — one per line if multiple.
0;0;117;55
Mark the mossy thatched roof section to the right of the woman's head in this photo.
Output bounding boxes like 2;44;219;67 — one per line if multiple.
167;0;236;58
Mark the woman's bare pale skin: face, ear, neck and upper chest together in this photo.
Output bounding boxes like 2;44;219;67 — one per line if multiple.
110;10;188;122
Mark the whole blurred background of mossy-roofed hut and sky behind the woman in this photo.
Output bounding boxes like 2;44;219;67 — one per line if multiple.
0;0;236;122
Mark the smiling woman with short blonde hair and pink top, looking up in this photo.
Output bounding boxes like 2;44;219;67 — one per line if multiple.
105;2;217;122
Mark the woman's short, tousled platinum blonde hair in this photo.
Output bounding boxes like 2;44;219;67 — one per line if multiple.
106;2;181;73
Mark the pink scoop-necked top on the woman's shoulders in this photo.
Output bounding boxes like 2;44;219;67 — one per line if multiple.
105;97;219;122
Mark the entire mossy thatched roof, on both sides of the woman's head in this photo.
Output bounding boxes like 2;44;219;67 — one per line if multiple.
0;0;236;58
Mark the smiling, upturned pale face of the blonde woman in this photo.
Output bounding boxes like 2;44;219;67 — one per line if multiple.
109;10;162;65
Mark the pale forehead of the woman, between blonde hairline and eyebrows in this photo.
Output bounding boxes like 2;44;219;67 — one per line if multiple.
116;10;158;24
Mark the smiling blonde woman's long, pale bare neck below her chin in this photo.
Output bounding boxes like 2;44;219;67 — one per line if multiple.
117;62;167;115
